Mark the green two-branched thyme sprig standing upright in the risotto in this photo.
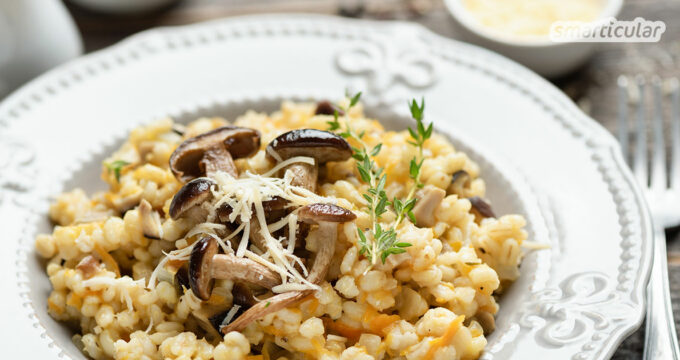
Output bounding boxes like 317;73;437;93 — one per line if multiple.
328;92;432;271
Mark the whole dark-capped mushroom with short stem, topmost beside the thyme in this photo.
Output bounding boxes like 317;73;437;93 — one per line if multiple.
267;129;352;192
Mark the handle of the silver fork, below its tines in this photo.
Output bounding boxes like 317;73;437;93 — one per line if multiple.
643;225;680;360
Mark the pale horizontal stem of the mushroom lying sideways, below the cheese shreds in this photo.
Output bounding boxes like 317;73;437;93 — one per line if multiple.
212;254;281;289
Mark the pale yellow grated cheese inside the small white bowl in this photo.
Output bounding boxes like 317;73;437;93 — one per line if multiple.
462;0;604;38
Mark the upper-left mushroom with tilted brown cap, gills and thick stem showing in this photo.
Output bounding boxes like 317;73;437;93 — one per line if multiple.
170;126;260;182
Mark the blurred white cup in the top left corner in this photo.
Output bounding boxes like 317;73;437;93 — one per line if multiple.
0;0;83;98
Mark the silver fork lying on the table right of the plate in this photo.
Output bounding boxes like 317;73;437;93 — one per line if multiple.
618;76;680;360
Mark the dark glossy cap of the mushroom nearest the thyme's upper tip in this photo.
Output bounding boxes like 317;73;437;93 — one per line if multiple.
267;129;352;164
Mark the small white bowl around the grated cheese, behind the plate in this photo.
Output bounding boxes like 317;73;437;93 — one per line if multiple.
444;0;623;78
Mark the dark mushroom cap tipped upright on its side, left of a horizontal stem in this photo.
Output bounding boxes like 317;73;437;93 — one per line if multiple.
189;236;219;300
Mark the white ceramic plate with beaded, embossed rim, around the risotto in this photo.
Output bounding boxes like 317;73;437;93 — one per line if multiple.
0;15;651;359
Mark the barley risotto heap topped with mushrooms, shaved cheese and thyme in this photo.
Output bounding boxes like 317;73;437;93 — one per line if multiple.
35;99;527;360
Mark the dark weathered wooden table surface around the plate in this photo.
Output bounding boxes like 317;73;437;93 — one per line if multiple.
68;0;680;359
